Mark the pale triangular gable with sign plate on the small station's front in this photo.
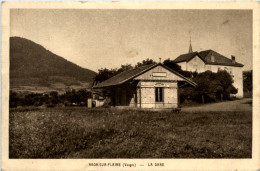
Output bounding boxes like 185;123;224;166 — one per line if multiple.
134;65;184;81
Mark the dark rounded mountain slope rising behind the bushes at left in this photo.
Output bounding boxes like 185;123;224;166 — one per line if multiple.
10;37;96;93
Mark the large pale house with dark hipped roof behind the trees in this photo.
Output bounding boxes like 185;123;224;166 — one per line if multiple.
174;48;244;98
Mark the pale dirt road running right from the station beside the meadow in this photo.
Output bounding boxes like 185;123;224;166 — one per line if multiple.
181;98;252;112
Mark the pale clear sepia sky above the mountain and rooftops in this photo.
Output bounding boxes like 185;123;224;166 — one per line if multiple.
10;9;252;72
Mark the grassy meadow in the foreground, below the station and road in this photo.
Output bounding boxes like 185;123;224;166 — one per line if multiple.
9;108;252;158
